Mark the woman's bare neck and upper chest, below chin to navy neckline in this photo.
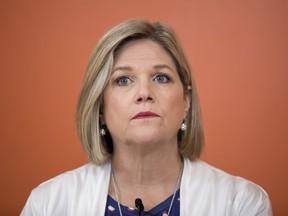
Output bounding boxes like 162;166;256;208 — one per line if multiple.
109;139;182;210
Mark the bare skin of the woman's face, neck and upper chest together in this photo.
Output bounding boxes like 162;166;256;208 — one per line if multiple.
103;39;190;210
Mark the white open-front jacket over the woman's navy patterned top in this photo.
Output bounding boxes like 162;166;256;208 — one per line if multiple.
21;159;272;216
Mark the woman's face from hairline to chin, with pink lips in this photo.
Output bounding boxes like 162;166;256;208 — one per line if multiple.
103;39;190;145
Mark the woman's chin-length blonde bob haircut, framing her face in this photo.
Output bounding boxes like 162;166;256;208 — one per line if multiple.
76;19;204;165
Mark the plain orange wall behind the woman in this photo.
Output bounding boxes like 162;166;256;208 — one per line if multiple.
0;0;288;215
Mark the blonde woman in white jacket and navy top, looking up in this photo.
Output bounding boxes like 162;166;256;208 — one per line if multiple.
22;20;272;216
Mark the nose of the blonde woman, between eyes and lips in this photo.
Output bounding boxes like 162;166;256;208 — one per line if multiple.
136;80;154;103
